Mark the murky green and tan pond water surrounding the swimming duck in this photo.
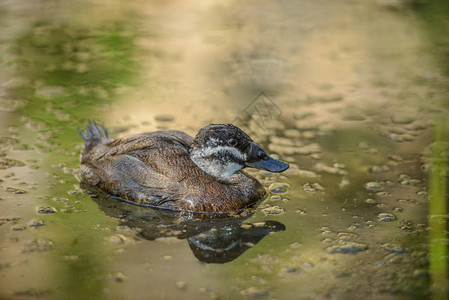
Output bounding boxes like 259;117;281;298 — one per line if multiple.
0;0;449;299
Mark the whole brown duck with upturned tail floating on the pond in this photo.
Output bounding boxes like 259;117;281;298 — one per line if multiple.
78;121;289;214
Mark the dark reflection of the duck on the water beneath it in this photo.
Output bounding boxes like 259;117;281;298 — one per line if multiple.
83;185;285;263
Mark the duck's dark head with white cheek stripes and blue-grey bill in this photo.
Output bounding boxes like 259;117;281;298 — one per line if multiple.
190;124;289;178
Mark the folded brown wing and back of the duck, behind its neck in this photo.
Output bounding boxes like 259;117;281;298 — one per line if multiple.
82;130;193;205
